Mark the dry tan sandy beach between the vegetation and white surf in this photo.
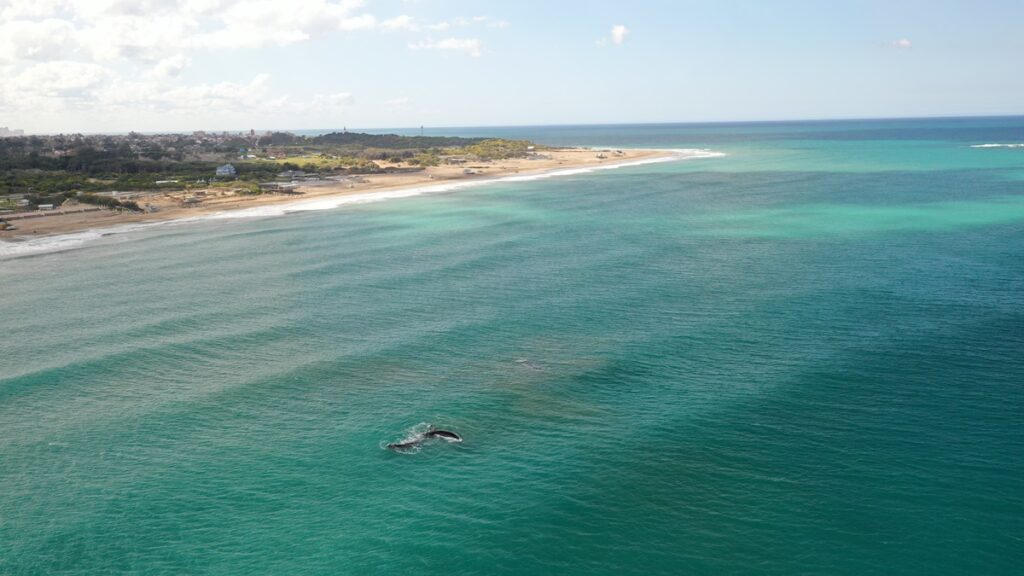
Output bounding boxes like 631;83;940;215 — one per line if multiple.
0;149;679;242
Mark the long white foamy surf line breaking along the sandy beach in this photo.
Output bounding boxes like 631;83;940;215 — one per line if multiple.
0;149;725;260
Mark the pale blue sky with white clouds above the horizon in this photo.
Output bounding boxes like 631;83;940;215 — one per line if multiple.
0;0;1024;133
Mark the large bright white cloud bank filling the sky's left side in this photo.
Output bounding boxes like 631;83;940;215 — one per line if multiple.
0;0;508;129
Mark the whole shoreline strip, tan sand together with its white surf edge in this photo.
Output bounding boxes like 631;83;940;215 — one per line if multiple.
0;148;724;260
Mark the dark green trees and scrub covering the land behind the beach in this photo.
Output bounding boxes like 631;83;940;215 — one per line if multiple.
0;132;532;209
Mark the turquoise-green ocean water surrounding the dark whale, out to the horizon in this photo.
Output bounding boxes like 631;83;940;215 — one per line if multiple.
0;118;1024;576
